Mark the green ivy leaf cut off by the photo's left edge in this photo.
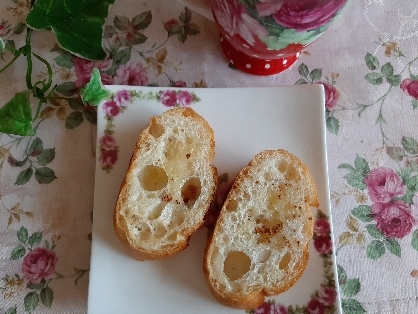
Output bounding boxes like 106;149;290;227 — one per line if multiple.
0;91;34;136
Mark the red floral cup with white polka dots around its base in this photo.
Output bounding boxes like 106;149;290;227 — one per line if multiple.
212;0;348;75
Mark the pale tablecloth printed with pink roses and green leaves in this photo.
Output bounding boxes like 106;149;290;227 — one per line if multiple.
0;0;418;314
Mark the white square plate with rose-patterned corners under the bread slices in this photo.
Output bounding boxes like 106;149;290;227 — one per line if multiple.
88;84;341;314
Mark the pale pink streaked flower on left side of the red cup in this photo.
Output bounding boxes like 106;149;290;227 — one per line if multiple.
212;0;268;45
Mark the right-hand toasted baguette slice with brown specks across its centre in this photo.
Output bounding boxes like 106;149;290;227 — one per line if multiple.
203;150;319;309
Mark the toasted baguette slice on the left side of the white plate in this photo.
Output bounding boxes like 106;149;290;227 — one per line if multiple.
113;108;218;260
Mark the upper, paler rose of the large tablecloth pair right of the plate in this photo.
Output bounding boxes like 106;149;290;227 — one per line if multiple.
364;167;406;203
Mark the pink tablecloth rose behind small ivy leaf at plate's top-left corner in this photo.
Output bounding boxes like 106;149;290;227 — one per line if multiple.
73;57;113;87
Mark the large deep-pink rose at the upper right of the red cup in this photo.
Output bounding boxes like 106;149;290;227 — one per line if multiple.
273;0;346;31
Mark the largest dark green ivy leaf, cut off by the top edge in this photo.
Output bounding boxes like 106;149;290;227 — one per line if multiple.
26;0;115;60
